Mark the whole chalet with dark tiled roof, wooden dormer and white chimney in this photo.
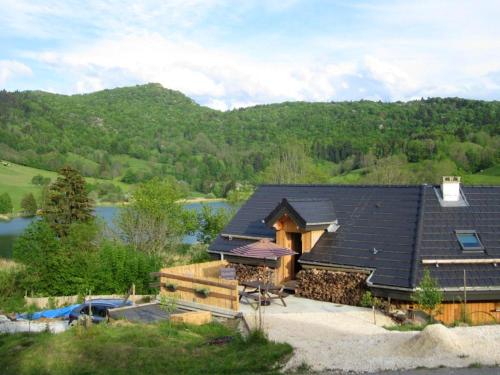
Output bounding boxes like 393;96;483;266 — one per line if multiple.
209;177;500;320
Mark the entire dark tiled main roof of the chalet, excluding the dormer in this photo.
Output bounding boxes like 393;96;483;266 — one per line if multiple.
210;185;500;288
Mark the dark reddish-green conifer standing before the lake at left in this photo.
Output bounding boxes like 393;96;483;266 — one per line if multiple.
42;167;94;236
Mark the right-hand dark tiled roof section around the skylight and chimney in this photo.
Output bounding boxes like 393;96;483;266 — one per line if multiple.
416;187;500;287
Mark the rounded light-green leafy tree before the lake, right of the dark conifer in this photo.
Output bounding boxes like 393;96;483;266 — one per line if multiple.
117;178;189;255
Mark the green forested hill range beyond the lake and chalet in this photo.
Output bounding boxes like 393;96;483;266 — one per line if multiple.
0;84;500;196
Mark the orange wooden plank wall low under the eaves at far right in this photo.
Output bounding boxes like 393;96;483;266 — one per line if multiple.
436;301;500;324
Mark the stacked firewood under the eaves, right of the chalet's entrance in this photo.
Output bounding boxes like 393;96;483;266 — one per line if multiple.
295;269;367;305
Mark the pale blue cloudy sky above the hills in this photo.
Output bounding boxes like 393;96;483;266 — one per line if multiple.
0;0;500;110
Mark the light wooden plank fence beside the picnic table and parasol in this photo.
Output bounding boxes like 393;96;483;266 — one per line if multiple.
152;260;240;311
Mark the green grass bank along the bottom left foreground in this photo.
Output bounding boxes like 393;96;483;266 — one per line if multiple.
0;322;292;375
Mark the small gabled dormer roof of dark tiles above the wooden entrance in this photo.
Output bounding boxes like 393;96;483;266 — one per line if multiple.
264;198;336;229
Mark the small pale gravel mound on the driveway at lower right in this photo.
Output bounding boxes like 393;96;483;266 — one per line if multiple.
400;324;465;357
